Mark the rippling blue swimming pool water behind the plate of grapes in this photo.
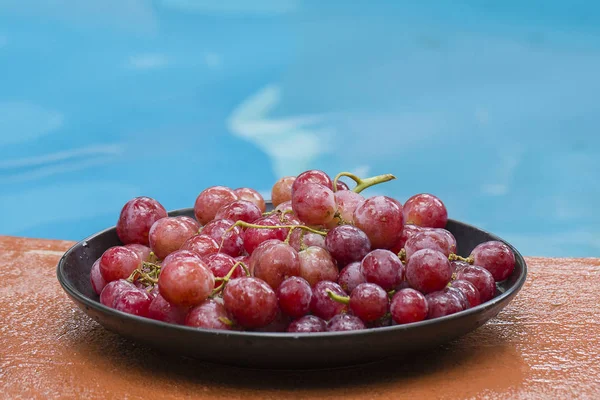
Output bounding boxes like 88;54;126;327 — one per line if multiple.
0;0;600;256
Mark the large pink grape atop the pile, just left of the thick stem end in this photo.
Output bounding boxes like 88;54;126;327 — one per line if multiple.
292;180;336;225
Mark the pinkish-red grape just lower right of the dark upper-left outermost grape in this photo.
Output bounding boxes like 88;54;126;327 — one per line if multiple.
149;217;197;260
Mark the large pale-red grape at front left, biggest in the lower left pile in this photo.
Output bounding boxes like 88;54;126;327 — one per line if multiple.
158;258;215;307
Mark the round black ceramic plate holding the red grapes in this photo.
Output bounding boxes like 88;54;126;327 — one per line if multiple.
57;209;527;369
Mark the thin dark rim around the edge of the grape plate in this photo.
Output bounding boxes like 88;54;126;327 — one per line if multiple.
56;208;527;340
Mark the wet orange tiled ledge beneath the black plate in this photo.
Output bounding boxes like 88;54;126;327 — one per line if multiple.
0;236;600;400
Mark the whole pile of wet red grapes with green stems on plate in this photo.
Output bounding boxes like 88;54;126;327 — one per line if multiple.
90;170;515;332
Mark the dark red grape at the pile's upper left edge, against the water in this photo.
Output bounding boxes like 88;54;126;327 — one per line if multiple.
117;197;167;246
